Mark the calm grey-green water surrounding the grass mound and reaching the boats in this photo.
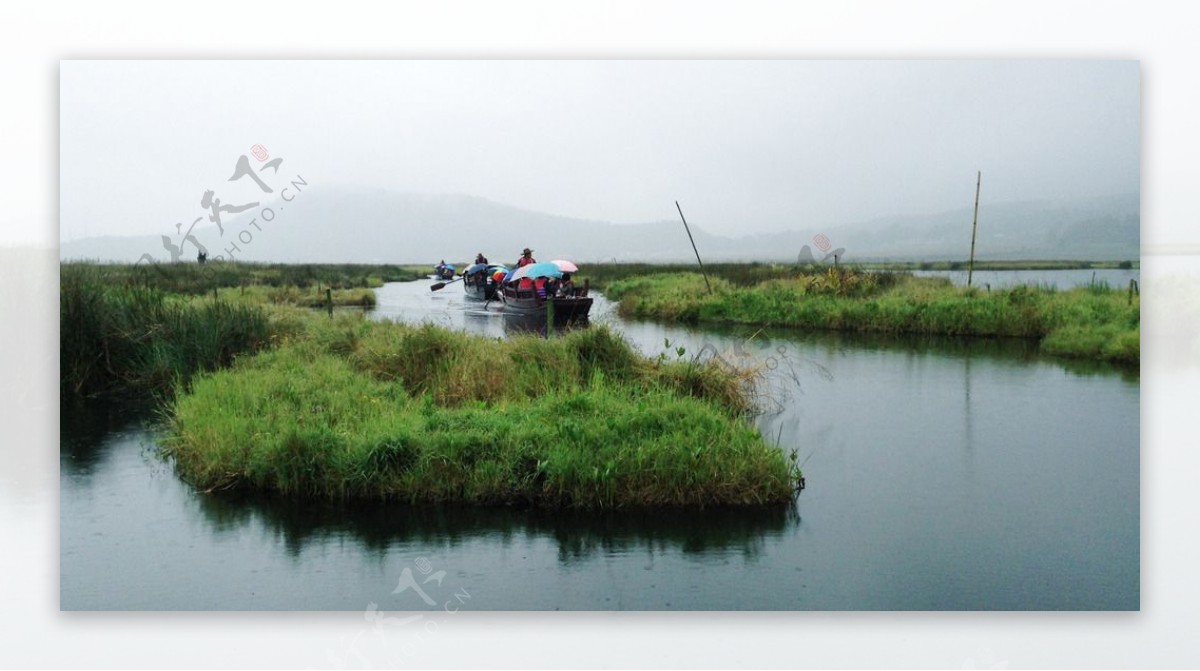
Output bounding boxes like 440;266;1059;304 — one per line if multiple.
61;277;1139;609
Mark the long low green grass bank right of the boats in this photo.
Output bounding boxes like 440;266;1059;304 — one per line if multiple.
607;269;1140;364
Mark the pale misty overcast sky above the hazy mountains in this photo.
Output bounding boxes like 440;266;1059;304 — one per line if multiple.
60;60;1140;240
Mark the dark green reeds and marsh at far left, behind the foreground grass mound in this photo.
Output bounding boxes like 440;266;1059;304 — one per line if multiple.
59;263;400;397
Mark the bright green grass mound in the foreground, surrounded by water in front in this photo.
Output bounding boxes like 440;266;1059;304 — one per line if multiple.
159;316;799;508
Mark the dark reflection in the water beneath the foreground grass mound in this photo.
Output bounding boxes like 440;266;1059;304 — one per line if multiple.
194;493;799;564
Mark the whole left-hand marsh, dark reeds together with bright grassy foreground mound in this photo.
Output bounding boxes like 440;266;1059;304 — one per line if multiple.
60;264;800;509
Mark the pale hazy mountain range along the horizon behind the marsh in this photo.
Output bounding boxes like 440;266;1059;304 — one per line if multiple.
60;188;1140;264
